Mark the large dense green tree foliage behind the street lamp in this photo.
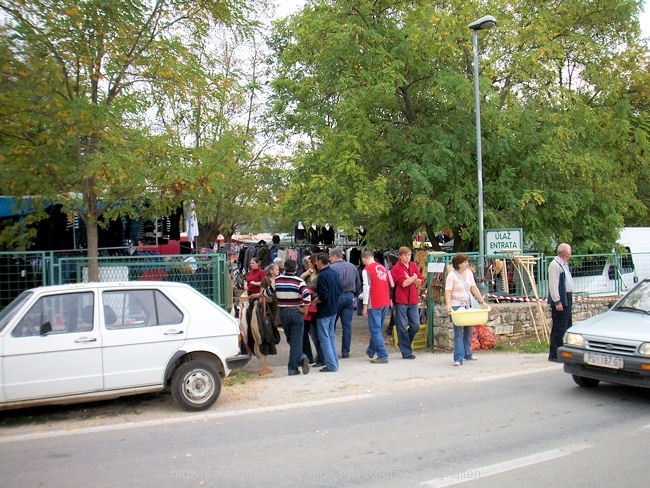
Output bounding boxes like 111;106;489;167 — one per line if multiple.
269;0;648;252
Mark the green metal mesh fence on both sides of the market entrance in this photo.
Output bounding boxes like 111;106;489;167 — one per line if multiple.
5;252;650;308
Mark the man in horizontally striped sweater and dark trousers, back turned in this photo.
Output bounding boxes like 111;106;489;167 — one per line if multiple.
263;259;311;376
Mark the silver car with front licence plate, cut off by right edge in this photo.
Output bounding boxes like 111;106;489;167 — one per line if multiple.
558;279;650;388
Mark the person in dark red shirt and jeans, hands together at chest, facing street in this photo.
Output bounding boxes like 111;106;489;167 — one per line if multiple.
390;246;424;359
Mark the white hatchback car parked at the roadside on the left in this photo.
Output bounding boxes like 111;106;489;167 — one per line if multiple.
0;281;248;410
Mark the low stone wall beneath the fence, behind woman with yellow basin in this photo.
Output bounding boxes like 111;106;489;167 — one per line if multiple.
433;298;612;350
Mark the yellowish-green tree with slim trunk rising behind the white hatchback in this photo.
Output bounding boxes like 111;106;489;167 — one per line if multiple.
0;0;256;280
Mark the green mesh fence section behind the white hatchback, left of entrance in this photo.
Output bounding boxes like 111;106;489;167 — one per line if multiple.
0;252;232;308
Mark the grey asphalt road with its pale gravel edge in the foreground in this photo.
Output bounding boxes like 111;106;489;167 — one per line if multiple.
0;353;650;488
